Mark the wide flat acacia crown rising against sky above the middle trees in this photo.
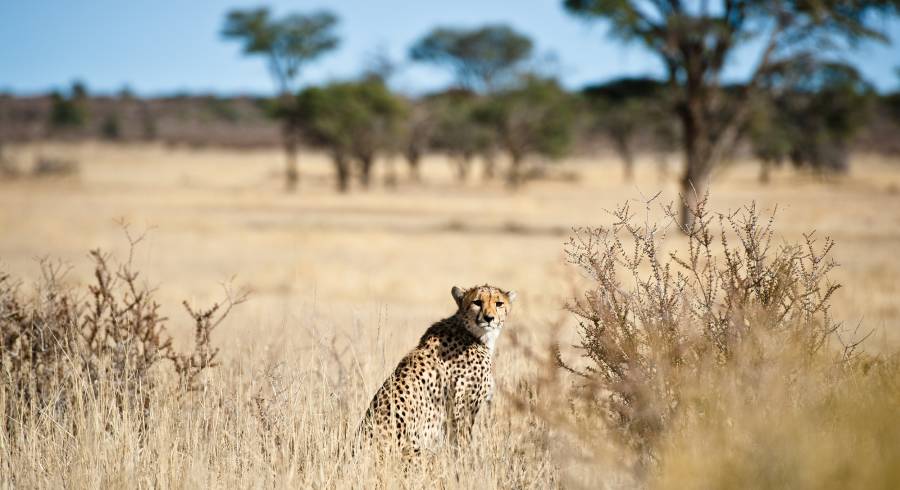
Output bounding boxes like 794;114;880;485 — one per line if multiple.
410;25;533;92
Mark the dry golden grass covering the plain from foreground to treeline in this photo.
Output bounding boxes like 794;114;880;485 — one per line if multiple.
0;143;900;488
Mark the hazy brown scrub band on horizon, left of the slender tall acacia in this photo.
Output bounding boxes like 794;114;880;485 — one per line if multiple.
0;87;281;147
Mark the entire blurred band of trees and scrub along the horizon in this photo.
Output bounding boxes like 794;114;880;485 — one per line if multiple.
0;0;900;234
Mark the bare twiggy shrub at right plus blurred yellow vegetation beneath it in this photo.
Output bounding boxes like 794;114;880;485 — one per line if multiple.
555;195;900;488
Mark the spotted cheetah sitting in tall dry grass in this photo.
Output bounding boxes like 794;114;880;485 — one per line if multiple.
357;284;516;455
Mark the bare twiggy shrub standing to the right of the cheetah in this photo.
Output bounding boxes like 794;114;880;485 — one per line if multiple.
556;198;855;473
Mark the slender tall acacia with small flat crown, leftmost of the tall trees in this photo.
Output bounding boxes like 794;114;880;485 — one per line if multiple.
222;7;338;191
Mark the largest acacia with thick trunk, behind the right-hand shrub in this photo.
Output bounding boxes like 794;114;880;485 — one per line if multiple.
563;0;896;229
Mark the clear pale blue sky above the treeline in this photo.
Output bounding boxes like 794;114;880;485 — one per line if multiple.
0;0;900;95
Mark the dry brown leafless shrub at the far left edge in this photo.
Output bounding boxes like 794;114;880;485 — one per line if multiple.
0;232;243;434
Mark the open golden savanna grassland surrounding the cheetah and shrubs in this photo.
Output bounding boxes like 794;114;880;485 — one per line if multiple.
0;144;900;488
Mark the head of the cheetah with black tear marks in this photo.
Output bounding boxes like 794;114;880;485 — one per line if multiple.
450;284;516;350
